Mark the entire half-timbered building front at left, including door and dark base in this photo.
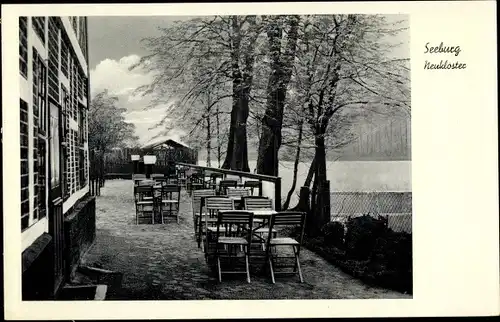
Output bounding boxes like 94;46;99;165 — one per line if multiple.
19;17;95;299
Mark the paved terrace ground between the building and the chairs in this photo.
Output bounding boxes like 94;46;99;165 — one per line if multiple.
82;180;411;300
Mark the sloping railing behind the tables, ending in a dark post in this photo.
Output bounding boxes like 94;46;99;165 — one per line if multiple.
176;162;281;211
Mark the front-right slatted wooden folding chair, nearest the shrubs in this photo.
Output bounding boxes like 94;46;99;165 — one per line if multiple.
266;211;306;284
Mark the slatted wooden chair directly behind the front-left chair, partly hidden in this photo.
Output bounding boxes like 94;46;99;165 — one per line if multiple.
198;196;234;250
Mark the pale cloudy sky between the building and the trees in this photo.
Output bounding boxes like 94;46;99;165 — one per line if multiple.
88;16;408;144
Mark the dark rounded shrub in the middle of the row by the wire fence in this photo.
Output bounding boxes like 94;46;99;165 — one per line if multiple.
345;215;388;259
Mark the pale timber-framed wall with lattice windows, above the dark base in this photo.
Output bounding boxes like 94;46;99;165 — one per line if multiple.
19;17;89;266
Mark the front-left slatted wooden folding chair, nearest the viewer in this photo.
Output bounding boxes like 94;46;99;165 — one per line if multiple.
215;210;253;283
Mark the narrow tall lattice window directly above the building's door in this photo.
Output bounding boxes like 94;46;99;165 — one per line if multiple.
48;17;59;102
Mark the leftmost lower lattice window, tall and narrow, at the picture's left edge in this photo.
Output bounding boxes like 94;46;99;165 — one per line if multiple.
20;100;30;230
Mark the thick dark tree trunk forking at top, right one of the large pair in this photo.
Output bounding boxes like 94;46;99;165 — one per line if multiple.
257;16;299;176
